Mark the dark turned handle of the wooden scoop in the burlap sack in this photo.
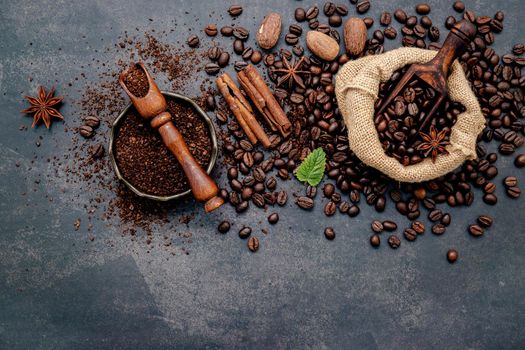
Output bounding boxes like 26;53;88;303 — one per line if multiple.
429;20;477;78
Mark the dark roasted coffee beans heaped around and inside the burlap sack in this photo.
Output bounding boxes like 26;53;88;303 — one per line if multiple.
204;0;525;261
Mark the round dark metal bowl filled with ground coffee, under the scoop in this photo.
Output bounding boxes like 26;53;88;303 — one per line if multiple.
110;92;217;201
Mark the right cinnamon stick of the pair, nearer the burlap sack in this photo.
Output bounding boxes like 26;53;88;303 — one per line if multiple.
237;64;292;137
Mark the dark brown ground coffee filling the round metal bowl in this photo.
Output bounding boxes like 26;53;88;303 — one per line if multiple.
115;98;212;196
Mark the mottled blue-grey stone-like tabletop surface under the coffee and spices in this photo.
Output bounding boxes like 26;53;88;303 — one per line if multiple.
0;0;525;349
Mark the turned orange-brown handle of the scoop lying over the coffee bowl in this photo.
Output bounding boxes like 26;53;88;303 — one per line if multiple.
151;112;224;213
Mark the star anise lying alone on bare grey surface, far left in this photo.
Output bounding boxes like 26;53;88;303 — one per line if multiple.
22;86;64;129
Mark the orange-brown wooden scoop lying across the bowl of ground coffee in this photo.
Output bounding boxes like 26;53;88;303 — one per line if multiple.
119;63;224;213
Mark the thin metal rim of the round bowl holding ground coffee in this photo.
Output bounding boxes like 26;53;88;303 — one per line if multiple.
108;91;218;202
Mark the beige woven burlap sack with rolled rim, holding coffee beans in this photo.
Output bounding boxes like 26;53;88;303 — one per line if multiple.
335;48;485;182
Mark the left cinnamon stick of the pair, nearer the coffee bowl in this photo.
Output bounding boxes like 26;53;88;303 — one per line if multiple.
216;73;271;148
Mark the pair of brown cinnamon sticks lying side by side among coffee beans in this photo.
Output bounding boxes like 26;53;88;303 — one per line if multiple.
217;65;292;148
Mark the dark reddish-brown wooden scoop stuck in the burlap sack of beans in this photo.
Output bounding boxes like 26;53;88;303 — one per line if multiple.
378;20;477;131
